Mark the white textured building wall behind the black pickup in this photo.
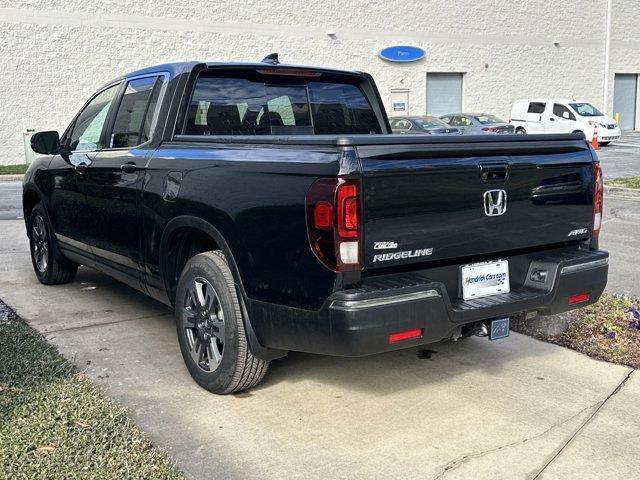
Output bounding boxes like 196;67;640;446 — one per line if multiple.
0;0;640;164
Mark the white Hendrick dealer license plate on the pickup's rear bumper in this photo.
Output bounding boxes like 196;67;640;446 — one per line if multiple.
460;260;509;300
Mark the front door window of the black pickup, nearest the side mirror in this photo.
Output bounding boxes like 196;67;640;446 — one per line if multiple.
68;85;119;152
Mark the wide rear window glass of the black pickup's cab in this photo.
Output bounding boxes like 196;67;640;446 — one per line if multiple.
184;72;382;135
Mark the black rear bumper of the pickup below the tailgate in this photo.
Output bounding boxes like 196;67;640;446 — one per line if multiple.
252;250;609;356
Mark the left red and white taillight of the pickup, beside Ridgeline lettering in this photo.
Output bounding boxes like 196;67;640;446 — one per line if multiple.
306;178;361;272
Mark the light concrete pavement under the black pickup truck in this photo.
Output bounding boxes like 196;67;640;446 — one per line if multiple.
0;221;640;479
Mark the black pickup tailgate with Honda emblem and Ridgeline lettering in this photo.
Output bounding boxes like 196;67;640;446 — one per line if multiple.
357;136;594;269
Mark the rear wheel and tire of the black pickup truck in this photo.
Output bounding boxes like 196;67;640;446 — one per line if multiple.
175;250;269;394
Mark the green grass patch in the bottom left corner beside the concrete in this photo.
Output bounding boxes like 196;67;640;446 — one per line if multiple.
0;302;183;480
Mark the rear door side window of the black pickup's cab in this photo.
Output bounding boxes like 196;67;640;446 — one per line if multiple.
110;77;162;148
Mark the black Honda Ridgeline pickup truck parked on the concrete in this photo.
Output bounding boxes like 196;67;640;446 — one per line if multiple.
23;57;608;394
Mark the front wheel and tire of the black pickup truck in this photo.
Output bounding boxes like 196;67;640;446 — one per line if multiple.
29;203;78;285
